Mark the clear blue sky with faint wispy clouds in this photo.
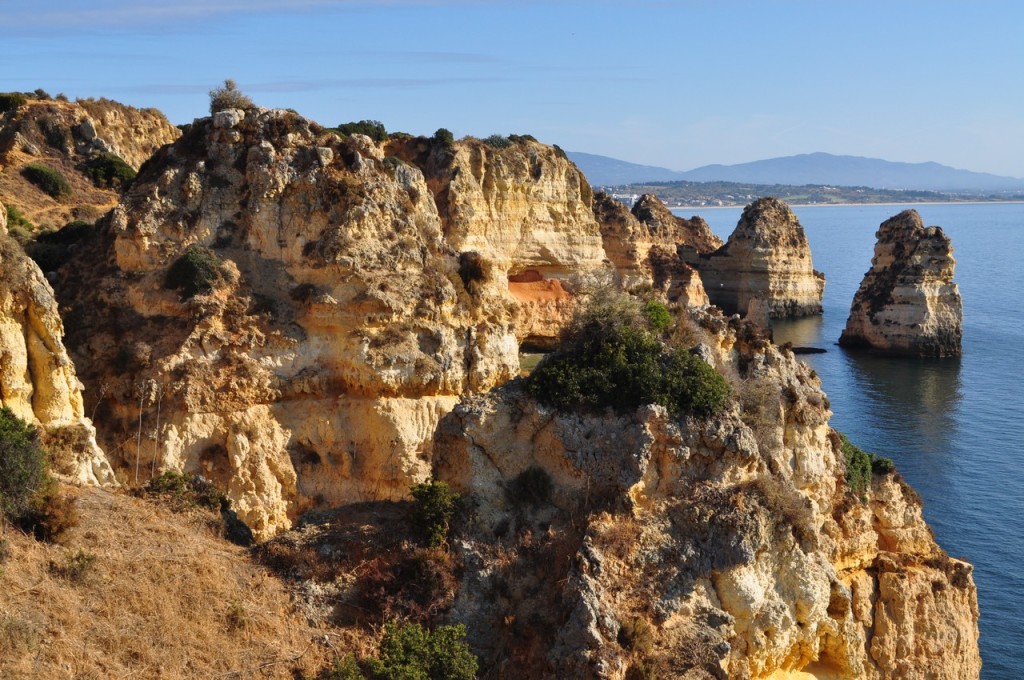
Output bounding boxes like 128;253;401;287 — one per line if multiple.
0;0;1024;177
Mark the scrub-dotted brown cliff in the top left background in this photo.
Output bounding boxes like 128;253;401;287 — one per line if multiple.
0;98;181;228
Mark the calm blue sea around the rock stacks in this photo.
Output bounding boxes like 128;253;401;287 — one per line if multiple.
676;204;1024;680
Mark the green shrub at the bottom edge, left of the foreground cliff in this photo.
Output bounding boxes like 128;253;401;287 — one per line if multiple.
367;624;478;680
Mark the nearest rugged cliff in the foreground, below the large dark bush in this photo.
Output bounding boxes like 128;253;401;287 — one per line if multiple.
434;312;980;679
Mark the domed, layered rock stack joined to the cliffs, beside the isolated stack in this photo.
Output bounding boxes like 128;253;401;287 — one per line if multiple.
686;198;824;318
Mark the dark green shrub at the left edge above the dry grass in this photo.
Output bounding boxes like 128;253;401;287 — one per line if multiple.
0;407;50;522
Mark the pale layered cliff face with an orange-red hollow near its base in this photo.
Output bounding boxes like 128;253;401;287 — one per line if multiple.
388;136;612;348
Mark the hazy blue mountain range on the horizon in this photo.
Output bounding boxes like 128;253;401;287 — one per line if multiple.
567;152;1024;194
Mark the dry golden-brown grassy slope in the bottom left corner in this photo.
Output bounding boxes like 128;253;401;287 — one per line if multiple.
0;488;333;679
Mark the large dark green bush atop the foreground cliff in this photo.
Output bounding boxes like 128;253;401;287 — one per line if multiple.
526;299;729;417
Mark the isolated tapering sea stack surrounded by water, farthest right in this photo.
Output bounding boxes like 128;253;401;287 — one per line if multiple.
839;210;964;356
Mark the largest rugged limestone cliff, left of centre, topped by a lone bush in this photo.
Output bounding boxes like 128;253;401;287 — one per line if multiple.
60;109;536;538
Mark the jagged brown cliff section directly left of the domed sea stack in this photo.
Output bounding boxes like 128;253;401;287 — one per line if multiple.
594;193;704;307
